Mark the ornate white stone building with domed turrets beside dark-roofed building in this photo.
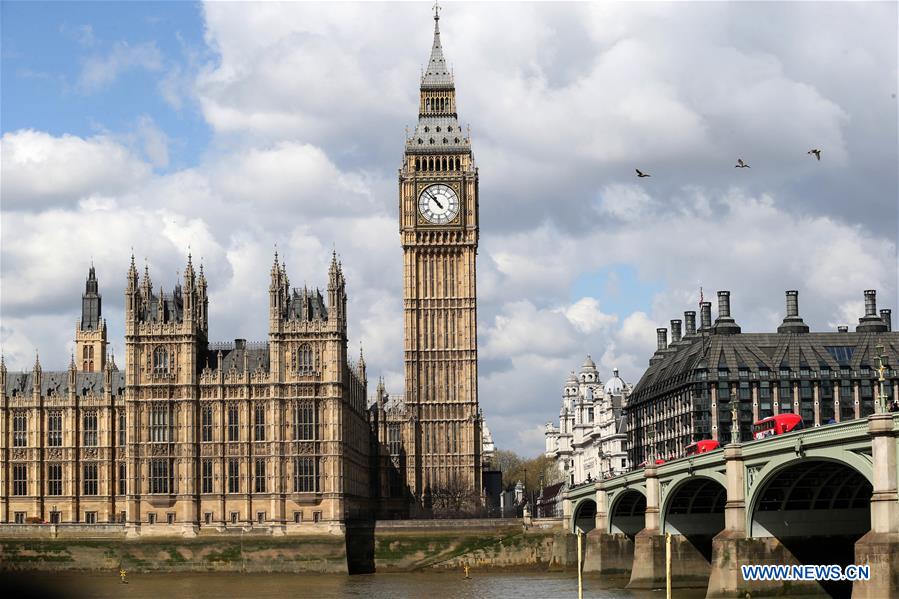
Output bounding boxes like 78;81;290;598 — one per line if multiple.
545;356;633;485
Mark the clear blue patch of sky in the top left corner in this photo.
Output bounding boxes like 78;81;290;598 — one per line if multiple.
0;2;211;171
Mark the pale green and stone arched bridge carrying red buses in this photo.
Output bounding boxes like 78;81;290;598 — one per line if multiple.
563;413;899;598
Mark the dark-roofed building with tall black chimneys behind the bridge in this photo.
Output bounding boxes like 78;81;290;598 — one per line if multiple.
627;290;899;464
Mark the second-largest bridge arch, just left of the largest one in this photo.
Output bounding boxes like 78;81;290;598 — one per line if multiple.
660;472;727;562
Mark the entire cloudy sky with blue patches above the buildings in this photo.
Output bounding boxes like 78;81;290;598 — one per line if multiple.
0;2;899;455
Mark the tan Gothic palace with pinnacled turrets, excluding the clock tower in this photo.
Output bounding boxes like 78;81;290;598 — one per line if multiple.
0;254;371;534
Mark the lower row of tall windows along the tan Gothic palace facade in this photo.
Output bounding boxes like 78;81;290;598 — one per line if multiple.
12;457;320;496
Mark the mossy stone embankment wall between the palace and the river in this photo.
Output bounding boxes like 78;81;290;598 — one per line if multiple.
0;520;560;573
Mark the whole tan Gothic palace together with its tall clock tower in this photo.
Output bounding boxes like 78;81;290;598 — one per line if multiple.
0;8;481;535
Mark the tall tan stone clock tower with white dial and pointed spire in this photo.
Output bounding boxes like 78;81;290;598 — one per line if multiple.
399;5;481;508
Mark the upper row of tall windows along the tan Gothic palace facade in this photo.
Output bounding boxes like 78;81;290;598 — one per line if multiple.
12;403;316;447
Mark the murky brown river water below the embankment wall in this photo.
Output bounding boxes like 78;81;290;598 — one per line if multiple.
7;572;705;599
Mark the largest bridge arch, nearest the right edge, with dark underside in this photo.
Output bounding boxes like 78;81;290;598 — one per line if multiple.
747;452;873;597
